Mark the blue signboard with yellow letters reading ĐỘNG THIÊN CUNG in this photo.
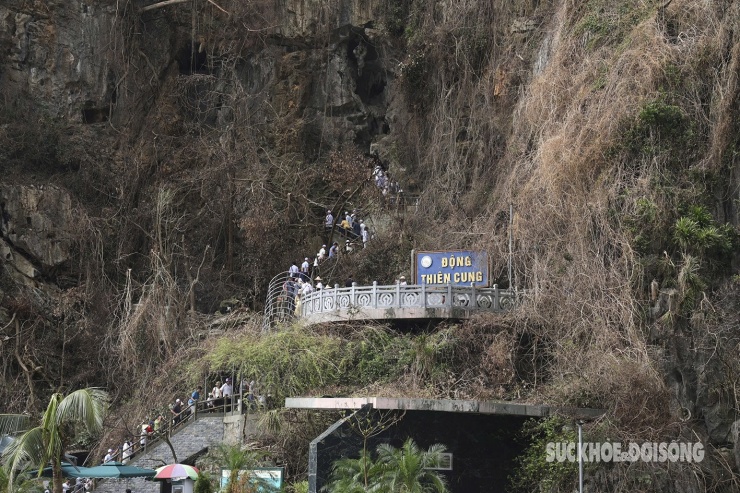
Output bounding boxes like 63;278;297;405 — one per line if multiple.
415;250;488;286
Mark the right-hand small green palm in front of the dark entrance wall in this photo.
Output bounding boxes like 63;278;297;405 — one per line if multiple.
378;438;448;493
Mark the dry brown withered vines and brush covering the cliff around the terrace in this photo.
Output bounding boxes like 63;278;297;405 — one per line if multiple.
0;0;740;488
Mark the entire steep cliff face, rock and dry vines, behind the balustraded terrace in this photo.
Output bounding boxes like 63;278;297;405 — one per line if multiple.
0;0;740;491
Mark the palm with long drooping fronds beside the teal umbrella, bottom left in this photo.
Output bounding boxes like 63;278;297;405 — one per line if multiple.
0;388;109;493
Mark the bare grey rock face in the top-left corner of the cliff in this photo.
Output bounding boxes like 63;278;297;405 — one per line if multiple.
0;1;117;121
